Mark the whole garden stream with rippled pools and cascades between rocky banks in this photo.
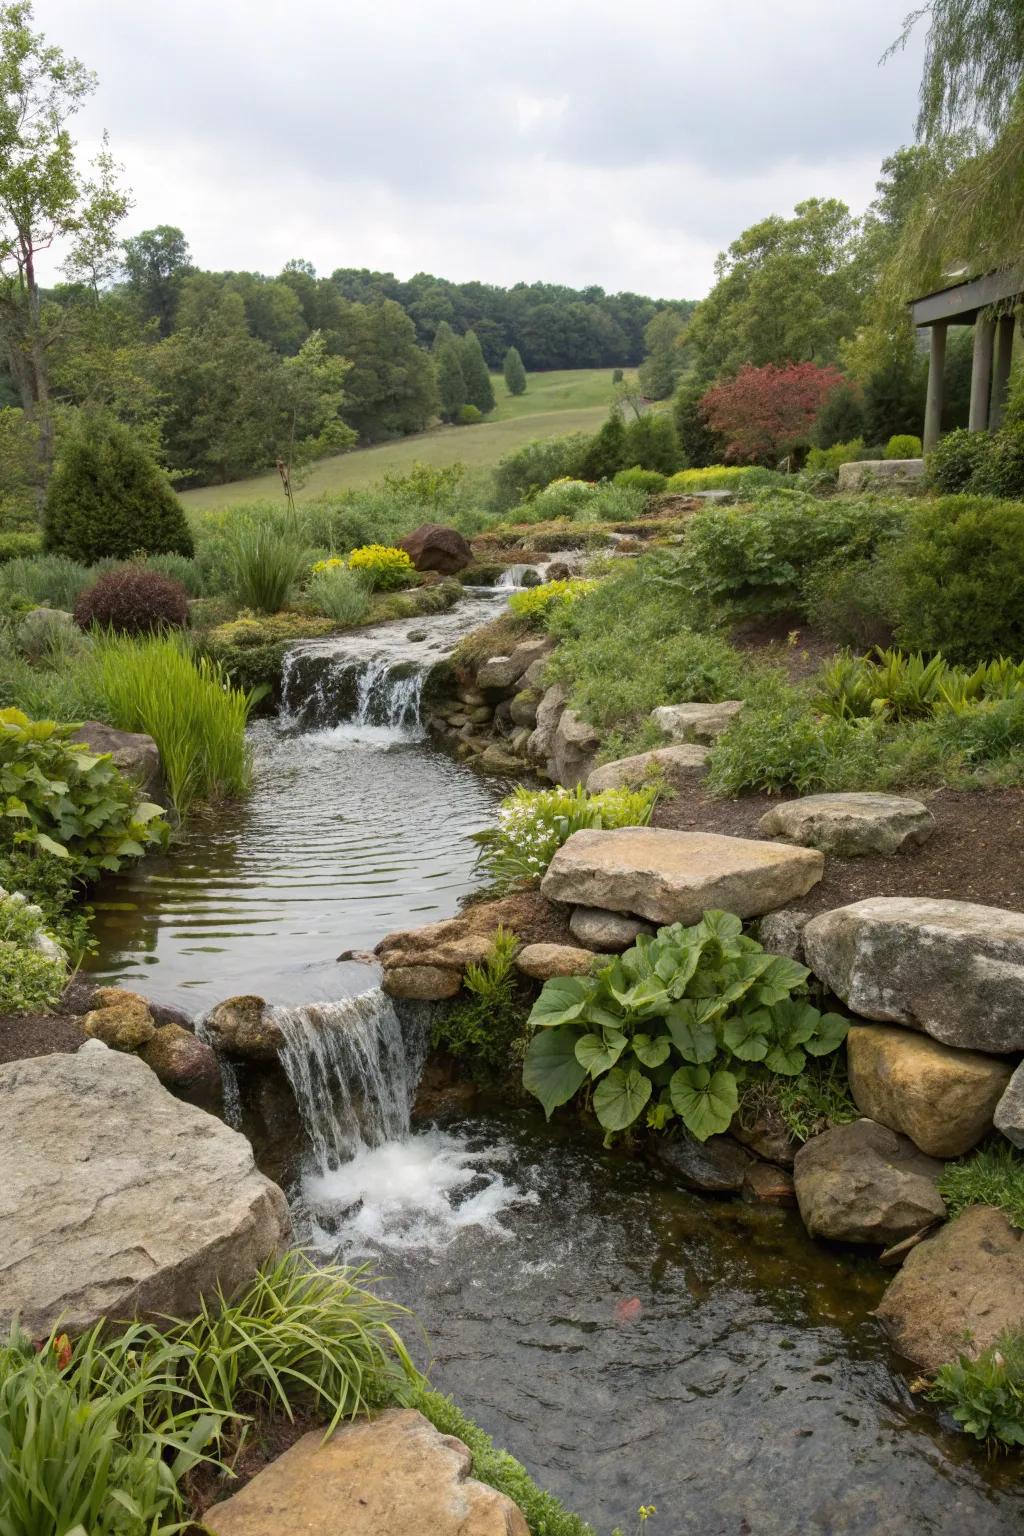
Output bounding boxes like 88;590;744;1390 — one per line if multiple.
84;593;1024;1536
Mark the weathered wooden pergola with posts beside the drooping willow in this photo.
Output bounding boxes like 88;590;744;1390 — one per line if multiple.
907;269;1024;453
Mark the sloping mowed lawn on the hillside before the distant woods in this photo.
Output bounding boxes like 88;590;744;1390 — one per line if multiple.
181;369;626;511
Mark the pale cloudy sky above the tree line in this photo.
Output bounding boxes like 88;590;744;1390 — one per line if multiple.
35;0;923;298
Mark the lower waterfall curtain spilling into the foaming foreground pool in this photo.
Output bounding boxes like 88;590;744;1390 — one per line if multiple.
273;988;428;1174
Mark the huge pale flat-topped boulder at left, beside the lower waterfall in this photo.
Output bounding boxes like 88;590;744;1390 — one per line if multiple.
0;1040;290;1338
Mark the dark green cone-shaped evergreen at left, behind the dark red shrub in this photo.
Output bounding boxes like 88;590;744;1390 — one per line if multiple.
46;413;193;565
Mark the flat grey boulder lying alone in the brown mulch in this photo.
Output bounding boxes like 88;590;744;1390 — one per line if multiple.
757;794;935;859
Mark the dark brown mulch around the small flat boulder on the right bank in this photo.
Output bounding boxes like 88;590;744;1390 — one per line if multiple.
654;790;1024;912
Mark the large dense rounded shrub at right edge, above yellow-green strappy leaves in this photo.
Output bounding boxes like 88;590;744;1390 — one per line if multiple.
894;496;1024;662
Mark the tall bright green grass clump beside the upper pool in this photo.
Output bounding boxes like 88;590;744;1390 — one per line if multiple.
94;634;258;816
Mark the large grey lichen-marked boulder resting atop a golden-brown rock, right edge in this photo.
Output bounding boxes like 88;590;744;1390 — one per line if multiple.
803;895;1024;1052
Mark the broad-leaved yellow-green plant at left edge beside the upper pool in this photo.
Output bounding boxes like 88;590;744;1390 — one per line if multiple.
0;710;167;880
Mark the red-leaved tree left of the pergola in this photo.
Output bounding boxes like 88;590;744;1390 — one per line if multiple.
700;362;843;465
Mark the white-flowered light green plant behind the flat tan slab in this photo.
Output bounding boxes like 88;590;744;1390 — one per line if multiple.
473;785;657;891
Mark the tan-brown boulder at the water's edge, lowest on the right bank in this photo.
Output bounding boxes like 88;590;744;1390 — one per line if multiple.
877;1206;1024;1375
